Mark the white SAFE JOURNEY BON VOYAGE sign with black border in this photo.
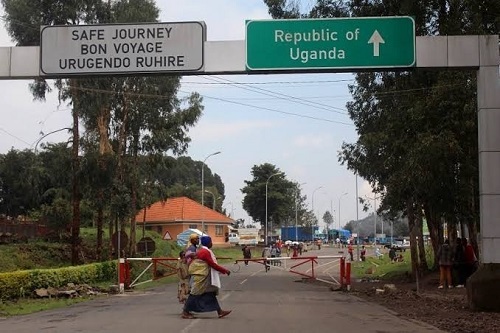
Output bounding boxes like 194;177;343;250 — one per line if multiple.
40;22;206;76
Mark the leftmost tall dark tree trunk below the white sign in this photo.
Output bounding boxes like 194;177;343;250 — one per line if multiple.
70;80;81;265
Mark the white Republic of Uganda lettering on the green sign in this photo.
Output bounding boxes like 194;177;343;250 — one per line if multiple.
274;28;360;64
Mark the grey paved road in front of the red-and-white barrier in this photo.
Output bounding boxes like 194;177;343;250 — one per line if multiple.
0;246;446;333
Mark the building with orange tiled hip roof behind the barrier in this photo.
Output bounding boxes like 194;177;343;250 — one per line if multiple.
135;197;235;246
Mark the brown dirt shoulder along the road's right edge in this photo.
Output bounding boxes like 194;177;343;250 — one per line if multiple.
351;274;500;333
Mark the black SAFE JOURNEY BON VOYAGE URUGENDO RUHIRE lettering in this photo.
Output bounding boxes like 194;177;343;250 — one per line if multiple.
59;27;185;70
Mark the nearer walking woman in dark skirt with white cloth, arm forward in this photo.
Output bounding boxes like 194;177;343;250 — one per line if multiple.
182;236;231;319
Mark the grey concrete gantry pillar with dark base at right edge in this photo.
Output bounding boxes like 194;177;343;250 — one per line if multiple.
467;36;500;311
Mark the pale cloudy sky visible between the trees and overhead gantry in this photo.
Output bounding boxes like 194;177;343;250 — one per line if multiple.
0;0;371;226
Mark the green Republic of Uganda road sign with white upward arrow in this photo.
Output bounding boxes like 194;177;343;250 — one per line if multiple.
246;16;415;71
